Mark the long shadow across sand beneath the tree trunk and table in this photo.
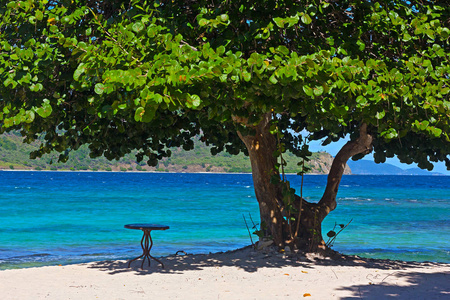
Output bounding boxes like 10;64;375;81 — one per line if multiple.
88;246;448;275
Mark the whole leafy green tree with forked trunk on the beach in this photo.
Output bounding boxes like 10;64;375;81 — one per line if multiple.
0;0;450;251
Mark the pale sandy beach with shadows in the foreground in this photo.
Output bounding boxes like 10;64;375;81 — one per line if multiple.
0;247;450;300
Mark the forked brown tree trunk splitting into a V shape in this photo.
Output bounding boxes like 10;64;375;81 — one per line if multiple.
238;114;372;252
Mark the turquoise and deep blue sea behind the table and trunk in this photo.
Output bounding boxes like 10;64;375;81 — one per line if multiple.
0;171;450;269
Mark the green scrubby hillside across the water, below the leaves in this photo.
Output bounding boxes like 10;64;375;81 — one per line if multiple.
0;134;350;174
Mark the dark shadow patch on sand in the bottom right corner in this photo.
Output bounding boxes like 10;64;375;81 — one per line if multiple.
338;271;450;300
